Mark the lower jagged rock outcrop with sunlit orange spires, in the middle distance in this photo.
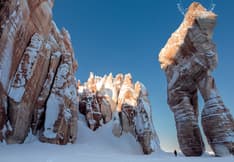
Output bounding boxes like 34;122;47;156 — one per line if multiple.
78;73;159;154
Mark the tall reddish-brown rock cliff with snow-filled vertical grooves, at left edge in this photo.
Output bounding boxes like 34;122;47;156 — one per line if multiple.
0;0;78;144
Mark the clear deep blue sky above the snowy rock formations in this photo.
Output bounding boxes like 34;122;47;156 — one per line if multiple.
53;0;234;151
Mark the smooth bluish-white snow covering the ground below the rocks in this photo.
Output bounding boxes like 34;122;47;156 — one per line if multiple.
0;122;234;162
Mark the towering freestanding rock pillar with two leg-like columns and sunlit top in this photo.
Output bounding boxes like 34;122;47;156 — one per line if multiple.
159;2;234;156
